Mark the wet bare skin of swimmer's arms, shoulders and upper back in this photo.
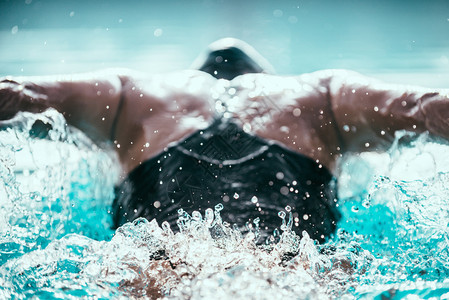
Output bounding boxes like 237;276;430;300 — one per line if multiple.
0;70;449;176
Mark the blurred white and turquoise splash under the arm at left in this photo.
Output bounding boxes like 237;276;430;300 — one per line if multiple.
0;110;118;264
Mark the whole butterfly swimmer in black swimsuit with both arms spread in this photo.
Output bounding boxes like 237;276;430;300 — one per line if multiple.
0;39;449;242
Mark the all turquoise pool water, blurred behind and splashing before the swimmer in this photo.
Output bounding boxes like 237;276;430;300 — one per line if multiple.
0;0;449;299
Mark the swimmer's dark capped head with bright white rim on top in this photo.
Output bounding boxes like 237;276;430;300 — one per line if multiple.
194;38;273;80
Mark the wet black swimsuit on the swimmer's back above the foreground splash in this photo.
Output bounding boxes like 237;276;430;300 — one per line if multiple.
113;118;340;241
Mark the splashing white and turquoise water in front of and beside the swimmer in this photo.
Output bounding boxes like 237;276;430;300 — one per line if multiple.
0;110;449;299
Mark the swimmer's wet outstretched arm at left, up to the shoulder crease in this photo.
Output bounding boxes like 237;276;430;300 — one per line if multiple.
0;71;131;141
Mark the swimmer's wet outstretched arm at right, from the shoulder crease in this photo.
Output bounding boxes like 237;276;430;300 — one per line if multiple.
328;70;449;152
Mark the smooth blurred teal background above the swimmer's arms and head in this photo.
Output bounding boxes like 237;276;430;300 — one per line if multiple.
0;0;449;87
